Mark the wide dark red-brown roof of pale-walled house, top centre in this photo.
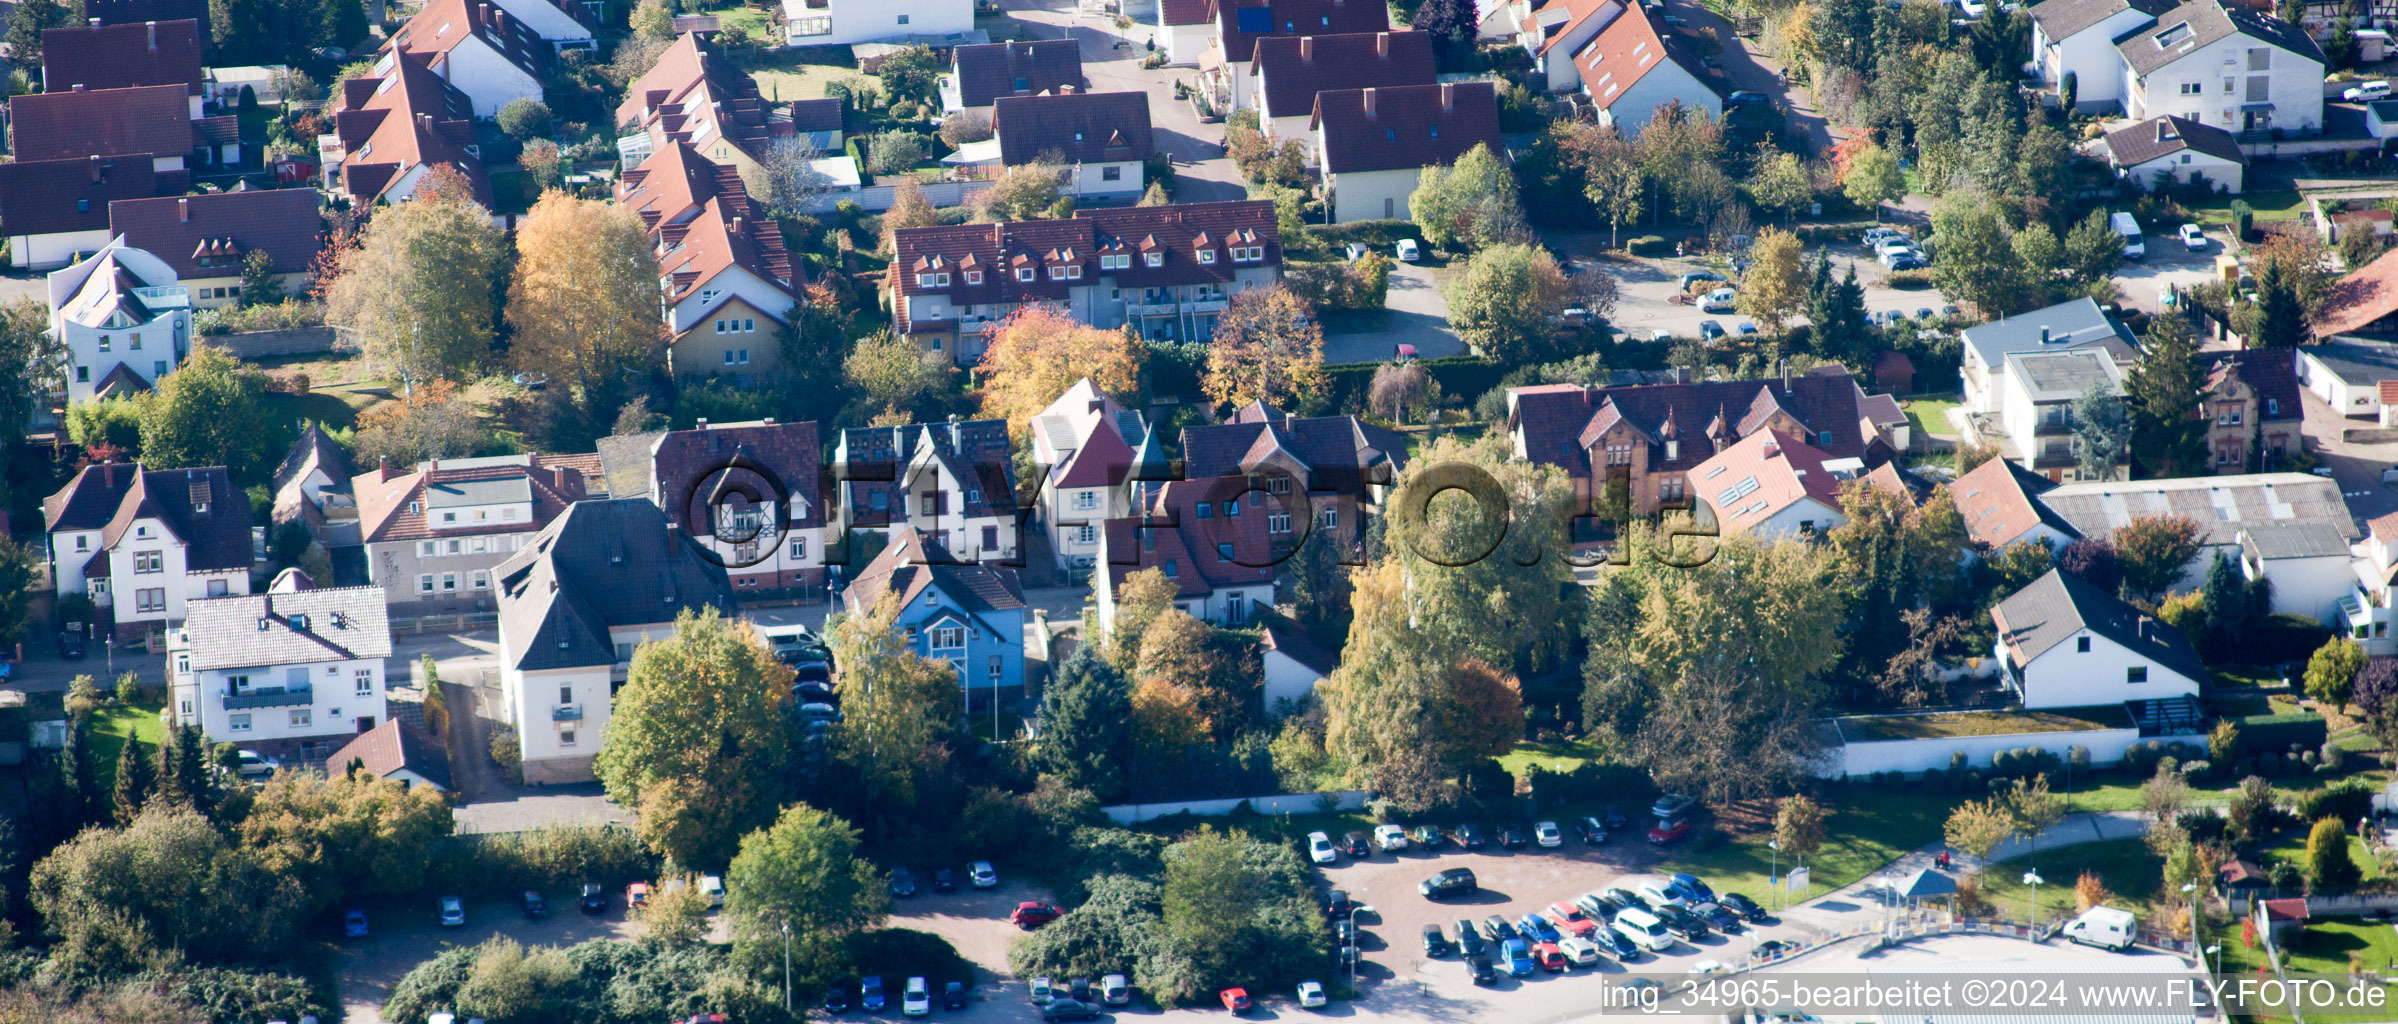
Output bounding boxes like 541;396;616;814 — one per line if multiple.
1312;82;1506;175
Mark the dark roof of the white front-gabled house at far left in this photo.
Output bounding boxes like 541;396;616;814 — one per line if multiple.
41;463;252;571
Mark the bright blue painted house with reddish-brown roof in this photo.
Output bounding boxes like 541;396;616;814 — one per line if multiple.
842;528;1031;710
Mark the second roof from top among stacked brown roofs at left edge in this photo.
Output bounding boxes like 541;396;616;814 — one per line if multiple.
7;84;199;161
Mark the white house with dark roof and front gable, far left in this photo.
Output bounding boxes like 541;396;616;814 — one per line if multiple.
41;463;254;628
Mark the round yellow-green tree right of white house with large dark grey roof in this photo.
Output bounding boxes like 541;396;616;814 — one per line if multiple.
592;609;791;868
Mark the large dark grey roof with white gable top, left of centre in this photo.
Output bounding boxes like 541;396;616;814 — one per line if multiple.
494;499;734;669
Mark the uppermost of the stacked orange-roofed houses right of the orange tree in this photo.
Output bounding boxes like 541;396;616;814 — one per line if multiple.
616;31;800;173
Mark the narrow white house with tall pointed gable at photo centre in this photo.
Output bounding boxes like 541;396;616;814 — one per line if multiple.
1031;377;1168;571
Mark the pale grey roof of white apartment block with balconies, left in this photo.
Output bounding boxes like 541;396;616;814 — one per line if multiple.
182;588;391;669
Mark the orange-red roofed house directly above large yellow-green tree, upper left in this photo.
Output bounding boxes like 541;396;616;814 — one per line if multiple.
317;53;492;209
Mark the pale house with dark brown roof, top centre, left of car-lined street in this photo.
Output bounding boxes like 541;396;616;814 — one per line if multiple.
990;91;1158;204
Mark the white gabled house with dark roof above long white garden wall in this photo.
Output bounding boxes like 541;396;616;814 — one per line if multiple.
1990;568;2209;731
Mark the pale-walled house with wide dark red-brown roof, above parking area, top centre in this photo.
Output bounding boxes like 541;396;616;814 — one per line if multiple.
1309;82;1506;223
